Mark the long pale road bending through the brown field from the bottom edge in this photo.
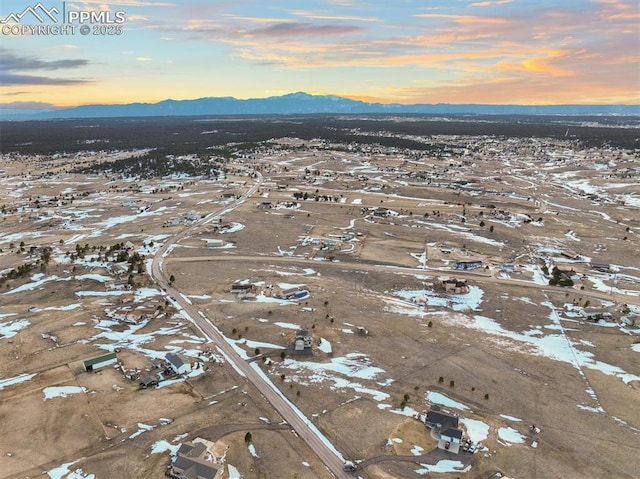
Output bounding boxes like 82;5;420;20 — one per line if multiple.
151;174;350;478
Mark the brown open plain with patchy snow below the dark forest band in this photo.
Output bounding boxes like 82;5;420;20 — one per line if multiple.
0;119;640;479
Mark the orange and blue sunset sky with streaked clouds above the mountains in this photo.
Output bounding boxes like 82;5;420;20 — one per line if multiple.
0;0;640;109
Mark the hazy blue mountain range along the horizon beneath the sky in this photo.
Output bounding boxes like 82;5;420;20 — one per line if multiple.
0;92;640;120
